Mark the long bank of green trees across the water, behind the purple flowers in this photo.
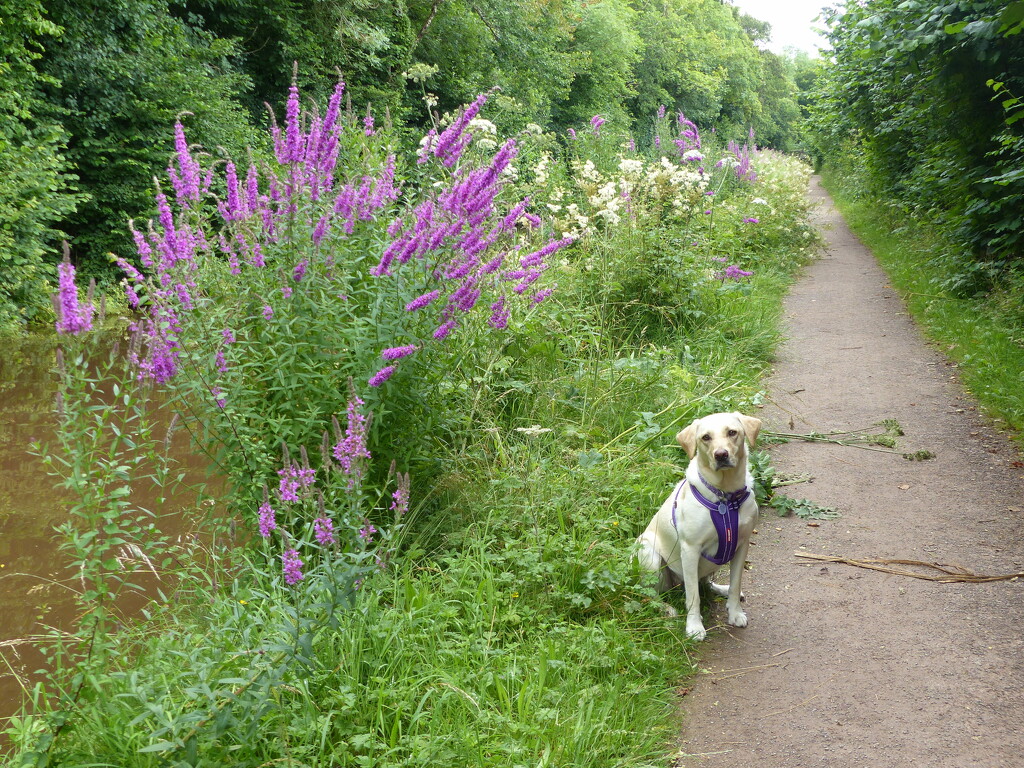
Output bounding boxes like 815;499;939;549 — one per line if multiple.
0;0;799;326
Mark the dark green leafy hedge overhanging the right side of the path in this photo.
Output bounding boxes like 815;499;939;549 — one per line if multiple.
813;0;1024;296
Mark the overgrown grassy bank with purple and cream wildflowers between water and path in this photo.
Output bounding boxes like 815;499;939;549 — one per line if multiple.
7;76;815;768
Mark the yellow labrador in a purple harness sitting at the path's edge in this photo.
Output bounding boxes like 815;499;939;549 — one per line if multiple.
637;413;761;640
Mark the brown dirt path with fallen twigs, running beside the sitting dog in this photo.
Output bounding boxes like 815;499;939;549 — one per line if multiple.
677;181;1024;768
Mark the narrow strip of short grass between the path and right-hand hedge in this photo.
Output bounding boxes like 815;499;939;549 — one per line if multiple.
822;173;1024;441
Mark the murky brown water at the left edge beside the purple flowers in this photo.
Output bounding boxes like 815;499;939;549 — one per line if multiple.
0;337;211;751
